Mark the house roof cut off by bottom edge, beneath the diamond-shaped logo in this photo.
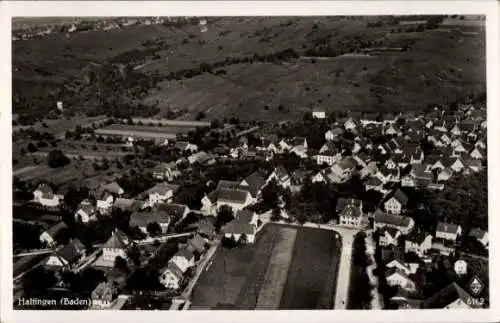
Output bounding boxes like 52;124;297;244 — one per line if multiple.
422;282;481;309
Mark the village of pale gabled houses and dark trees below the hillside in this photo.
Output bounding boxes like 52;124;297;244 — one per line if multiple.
14;98;488;310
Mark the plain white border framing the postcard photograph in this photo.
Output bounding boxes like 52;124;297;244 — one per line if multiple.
0;0;500;323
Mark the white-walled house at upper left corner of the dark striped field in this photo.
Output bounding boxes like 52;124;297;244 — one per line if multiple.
221;210;258;243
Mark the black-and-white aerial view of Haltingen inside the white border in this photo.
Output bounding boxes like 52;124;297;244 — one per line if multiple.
9;14;490;311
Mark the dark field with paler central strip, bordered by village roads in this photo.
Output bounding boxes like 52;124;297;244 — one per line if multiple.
191;224;340;310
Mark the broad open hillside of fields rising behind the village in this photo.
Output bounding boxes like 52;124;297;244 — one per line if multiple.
13;17;486;121
